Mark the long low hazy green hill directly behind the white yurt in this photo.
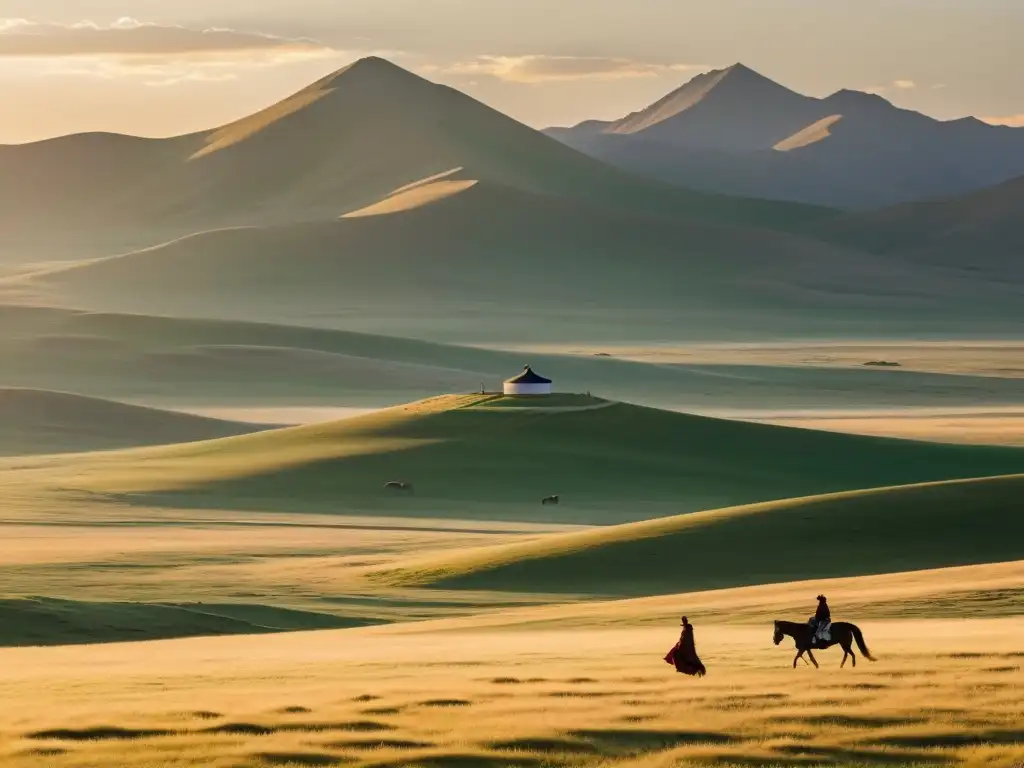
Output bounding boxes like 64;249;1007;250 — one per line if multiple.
6;305;1024;410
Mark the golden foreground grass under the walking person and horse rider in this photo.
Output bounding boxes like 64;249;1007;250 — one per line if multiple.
0;570;1024;768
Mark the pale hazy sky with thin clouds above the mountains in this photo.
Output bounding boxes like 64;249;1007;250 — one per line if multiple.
0;0;1024;142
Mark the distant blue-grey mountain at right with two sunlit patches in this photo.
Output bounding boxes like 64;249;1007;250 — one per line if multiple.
547;65;1024;209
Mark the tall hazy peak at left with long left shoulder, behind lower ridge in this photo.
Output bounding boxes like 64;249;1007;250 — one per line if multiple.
0;57;821;260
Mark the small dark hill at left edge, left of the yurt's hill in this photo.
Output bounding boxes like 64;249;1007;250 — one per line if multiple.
0;387;262;456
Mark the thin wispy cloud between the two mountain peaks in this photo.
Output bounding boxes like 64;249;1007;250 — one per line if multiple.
424;54;708;83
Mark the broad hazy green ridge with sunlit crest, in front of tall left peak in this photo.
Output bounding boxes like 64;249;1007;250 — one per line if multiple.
9;180;1024;339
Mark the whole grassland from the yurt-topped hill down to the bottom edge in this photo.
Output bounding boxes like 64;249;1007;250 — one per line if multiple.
0;380;1024;768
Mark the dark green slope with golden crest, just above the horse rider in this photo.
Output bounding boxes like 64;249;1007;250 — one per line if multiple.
373;475;1024;595
